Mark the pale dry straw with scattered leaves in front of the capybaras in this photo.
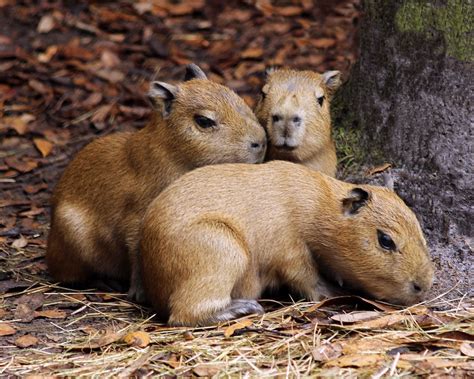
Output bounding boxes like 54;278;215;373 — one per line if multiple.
0;248;474;378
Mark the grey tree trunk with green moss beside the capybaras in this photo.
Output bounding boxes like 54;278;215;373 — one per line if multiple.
349;0;474;295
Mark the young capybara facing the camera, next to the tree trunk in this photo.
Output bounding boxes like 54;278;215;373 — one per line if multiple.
255;69;341;177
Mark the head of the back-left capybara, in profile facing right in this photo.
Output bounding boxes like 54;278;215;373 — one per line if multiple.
149;64;266;167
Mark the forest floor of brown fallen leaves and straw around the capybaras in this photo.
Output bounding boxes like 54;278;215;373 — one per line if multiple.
0;0;474;377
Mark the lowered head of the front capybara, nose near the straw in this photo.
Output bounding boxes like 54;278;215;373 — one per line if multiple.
322;186;434;305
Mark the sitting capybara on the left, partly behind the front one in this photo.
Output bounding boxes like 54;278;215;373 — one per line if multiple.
46;67;266;300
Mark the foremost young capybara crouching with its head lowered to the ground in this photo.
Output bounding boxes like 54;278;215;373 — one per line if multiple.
140;161;433;325
